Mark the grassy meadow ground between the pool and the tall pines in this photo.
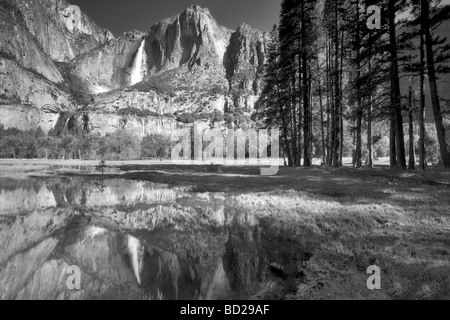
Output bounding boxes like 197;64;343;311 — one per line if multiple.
117;167;450;299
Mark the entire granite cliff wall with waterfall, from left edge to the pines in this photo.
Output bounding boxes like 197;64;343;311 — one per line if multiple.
0;0;268;135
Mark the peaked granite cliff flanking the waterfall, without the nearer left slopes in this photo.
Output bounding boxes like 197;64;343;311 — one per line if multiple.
72;6;268;135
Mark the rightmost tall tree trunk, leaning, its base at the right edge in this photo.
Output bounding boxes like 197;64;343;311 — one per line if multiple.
421;0;450;168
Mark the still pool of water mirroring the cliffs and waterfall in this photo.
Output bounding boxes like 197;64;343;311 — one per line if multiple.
0;178;265;299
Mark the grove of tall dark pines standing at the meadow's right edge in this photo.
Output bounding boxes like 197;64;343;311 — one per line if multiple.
258;0;450;169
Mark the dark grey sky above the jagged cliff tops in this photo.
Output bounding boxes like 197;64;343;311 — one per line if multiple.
67;0;281;36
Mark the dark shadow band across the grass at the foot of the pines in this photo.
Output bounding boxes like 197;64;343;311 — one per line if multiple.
114;165;450;201
